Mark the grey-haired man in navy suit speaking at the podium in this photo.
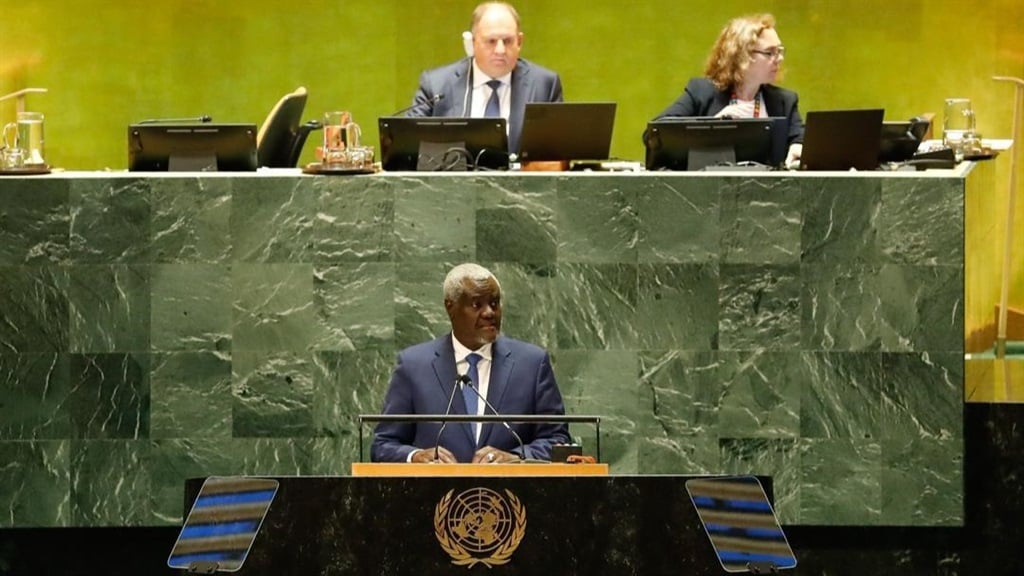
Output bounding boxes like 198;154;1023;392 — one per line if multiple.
371;263;568;463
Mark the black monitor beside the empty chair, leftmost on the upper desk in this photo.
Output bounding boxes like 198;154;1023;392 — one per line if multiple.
128;123;256;172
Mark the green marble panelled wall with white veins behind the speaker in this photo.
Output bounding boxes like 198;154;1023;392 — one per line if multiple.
0;173;965;527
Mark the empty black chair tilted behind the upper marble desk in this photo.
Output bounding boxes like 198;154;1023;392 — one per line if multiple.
256;86;323;168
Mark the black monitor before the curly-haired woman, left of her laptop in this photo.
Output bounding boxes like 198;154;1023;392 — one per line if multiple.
644;118;786;170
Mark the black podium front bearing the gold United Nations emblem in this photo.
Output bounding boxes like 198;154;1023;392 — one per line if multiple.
185;473;771;576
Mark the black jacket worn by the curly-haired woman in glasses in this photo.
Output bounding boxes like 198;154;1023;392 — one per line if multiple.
654;78;804;145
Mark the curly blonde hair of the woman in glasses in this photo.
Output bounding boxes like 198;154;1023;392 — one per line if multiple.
705;14;781;90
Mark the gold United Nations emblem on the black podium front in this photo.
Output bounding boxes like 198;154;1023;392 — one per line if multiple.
434;488;526;568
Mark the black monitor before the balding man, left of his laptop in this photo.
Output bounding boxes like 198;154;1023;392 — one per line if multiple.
378;116;509;171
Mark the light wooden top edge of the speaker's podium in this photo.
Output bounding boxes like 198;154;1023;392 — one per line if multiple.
352;462;608;477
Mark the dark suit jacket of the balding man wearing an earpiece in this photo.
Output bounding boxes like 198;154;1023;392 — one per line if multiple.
407;57;562;154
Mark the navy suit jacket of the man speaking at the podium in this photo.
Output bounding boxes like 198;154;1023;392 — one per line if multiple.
371;333;568;462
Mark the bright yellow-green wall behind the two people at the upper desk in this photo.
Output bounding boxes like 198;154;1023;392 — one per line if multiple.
0;0;1024;169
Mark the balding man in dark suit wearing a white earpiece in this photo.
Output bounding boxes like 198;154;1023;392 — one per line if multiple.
407;2;562;154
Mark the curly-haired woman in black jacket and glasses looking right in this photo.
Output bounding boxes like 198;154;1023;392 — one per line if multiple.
654;14;804;166
